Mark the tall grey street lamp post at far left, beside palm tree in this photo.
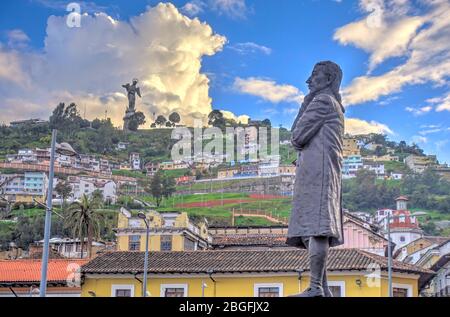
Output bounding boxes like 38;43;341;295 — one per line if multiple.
39;129;77;297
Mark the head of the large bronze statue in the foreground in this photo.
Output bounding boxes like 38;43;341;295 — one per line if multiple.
306;61;342;101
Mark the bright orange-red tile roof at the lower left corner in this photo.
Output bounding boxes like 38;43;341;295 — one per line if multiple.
0;259;88;284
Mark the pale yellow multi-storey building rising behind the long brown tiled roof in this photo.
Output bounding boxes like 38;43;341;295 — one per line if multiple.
115;208;212;251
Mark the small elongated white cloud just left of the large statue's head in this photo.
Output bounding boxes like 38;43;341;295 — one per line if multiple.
234;77;304;104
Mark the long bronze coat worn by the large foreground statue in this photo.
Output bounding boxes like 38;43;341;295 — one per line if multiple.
286;89;345;248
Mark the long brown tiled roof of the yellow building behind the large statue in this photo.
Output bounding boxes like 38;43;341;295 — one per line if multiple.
82;249;433;274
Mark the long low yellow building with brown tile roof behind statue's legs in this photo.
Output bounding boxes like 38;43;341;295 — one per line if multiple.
81;249;433;297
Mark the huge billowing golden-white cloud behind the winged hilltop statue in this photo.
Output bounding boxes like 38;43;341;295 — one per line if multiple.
0;4;232;124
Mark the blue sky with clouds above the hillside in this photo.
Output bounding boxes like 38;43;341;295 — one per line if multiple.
0;0;450;163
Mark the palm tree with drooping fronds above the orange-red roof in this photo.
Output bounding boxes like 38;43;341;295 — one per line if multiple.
66;194;103;258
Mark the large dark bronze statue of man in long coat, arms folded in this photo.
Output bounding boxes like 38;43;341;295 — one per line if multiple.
286;61;345;297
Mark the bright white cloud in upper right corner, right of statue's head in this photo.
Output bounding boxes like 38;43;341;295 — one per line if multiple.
335;0;450;109
